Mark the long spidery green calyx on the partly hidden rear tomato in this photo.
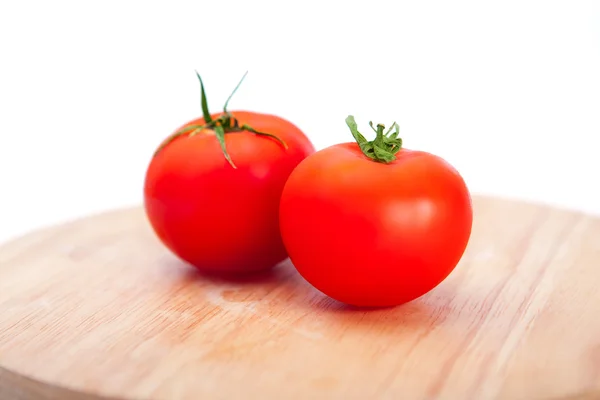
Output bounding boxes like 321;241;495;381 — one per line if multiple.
154;71;288;168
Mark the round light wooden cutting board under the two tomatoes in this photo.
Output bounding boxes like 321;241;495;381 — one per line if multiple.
0;197;600;400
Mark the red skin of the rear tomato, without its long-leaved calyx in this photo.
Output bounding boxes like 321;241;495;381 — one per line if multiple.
144;111;315;273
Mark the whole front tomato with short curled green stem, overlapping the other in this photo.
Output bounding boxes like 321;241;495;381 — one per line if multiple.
280;116;473;307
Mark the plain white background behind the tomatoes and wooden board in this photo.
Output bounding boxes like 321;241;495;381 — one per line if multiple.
0;0;600;240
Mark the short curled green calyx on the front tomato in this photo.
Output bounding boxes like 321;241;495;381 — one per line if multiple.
346;115;402;163
